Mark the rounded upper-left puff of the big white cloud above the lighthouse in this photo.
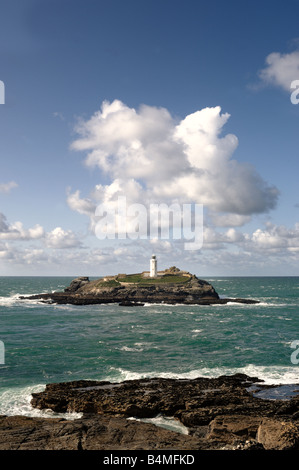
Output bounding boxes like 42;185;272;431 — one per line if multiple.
71;100;187;183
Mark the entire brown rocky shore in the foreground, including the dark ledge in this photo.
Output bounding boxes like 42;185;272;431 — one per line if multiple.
0;374;299;451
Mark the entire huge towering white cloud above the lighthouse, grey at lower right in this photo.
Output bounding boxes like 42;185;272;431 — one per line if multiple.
68;100;279;222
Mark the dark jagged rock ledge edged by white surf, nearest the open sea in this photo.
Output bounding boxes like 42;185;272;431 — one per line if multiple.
32;374;264;416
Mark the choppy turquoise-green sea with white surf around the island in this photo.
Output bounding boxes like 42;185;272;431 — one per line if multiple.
0;276;299;419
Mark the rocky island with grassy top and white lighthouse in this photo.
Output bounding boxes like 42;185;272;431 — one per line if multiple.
20;262;259;307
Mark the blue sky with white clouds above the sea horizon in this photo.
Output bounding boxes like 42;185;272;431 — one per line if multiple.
0;0;299;277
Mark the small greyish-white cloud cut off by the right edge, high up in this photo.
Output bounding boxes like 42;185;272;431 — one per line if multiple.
259;51;299;91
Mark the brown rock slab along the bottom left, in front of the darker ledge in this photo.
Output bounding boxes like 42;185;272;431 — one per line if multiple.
0;415;204;450
